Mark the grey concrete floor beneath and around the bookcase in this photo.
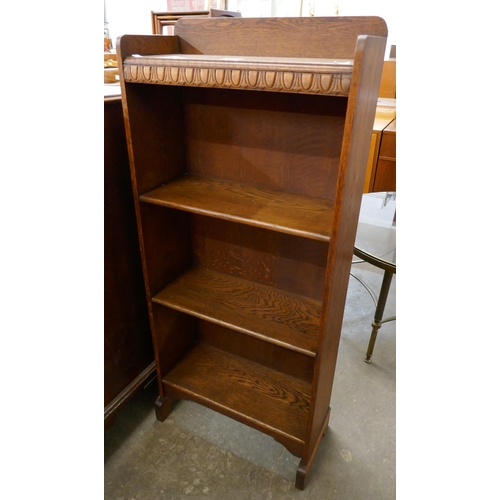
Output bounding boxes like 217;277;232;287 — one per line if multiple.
104;263;396;500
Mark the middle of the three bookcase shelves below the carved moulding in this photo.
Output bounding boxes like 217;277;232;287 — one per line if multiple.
152;268;321;357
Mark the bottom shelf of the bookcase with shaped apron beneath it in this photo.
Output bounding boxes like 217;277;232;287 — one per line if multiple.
162;342;311;456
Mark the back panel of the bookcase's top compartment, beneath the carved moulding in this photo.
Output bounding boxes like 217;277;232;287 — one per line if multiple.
184;88;347;199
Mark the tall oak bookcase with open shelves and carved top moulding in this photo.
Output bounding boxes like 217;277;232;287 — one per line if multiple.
118;17;387;489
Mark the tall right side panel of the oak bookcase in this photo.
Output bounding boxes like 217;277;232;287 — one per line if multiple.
304;36;386;460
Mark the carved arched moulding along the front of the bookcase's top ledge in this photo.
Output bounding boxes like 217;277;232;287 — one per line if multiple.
123;56;352;96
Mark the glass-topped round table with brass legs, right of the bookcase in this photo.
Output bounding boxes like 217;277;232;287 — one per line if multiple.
351;192;396;363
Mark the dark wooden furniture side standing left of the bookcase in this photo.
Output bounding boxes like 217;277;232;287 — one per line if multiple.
104;89;154;426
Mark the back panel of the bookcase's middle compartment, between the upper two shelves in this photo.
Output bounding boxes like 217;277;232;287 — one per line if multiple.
191;215;328;300
